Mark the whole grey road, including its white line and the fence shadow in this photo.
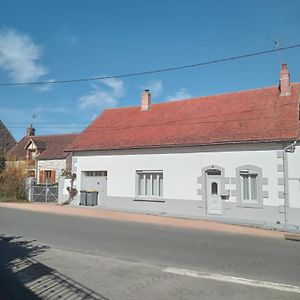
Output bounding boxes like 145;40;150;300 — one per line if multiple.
0;207;300;299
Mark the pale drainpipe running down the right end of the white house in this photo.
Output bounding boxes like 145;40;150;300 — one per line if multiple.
282;141;297;230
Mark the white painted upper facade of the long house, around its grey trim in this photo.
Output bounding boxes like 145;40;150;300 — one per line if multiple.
74;144;283;206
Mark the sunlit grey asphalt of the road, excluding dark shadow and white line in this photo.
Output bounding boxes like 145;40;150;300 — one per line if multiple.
0;208;300;299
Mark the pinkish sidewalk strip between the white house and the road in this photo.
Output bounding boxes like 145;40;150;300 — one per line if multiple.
0;203;284;239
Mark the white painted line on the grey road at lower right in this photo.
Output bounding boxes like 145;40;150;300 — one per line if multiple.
162;268;300;294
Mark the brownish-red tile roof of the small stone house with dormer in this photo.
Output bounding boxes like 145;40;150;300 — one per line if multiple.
12;134;78;160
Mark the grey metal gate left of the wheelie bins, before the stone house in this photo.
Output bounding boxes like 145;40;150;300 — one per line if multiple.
32;184;58;202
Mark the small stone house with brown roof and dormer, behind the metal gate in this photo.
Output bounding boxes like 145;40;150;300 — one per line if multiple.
12;126;77;184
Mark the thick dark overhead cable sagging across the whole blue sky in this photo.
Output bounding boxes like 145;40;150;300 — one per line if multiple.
0;44;300;86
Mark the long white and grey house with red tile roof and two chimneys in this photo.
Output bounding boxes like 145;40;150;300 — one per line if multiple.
66;64;300;229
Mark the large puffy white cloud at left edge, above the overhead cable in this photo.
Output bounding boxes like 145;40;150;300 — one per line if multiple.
0;29;48;82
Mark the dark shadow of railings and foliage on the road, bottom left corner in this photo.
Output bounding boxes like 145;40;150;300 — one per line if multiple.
0;235;109;300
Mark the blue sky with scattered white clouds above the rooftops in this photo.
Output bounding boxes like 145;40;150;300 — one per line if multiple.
0;0;300;140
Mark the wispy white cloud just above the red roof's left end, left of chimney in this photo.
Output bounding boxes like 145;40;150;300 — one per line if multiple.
78;78;125;109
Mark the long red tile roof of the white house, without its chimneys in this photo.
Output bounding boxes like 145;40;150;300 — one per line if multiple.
67;83;300;151
